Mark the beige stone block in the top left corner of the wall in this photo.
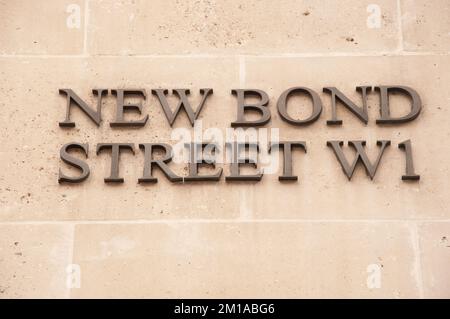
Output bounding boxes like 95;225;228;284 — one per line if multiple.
0;0;85;54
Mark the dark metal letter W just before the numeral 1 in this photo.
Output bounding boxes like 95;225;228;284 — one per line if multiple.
327;140;391;180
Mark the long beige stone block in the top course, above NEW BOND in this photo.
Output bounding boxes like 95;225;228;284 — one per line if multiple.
88;0;399;55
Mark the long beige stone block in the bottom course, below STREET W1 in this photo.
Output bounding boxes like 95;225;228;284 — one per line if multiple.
71;222;419;298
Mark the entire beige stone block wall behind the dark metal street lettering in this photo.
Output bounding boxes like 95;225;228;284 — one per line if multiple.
0;0;450;298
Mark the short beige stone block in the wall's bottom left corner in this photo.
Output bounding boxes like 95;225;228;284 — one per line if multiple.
0;224;74;298
